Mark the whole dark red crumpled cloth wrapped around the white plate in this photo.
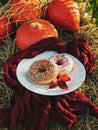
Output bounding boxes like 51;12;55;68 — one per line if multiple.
0;36;98;130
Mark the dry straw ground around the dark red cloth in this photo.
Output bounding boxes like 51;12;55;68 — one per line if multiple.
0;2;98;130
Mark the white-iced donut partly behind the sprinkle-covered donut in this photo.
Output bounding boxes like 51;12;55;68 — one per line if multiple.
50;54;74;75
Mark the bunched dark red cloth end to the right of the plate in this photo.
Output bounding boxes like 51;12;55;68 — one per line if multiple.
66;36;96;73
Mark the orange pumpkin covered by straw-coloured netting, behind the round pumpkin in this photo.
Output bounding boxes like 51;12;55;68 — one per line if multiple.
9;0;42;26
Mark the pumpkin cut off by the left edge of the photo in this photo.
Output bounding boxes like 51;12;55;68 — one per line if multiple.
0;14;13;45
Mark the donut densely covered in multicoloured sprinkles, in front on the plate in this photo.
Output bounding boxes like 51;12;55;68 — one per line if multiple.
28;59;58;84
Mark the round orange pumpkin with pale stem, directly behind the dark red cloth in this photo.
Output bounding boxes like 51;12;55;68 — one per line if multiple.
16;19;58;50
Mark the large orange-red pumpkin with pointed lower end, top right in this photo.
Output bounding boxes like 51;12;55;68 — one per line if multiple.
46;0;80;32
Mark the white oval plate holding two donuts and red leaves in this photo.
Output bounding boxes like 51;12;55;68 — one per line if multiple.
16;51;86;96
